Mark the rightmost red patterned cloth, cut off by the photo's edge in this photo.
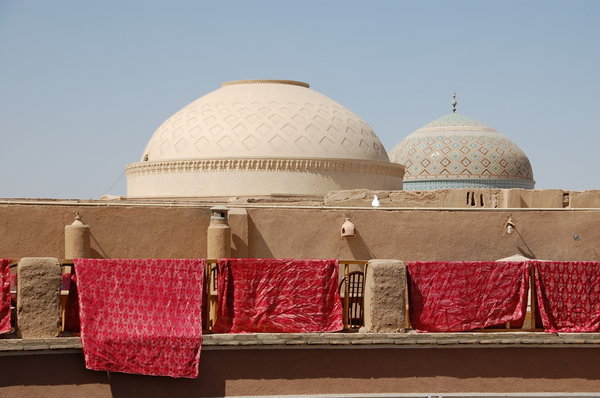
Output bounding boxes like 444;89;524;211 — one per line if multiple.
534;261;600;333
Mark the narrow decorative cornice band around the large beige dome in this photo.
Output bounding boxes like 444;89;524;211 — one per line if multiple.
125;158;404;178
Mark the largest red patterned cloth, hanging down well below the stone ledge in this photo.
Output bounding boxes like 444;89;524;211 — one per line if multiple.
75;259;204;378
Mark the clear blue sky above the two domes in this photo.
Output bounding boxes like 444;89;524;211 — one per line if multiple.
0;0;600;198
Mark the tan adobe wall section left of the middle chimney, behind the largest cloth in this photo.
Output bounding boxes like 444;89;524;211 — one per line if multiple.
0;205;210;259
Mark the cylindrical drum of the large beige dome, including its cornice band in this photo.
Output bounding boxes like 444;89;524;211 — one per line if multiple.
126;159;404;197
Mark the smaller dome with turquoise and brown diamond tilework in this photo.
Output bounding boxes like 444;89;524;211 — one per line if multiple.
389;113;535;190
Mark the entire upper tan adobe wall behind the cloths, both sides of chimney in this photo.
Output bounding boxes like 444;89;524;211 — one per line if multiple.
0;204;600;261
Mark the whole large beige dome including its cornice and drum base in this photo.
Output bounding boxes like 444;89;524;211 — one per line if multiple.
126;80;404;196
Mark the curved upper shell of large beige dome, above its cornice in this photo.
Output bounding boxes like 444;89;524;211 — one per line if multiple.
144;84;388;162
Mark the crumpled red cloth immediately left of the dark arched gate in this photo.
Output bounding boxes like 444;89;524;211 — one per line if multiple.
213;259;344;333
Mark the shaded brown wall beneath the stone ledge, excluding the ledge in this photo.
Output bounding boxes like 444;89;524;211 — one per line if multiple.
0;347;600;398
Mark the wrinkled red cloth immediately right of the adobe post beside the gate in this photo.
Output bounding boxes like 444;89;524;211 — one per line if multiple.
408;261;529;332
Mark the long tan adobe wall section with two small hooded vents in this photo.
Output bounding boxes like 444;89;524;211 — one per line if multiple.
248;208;600;261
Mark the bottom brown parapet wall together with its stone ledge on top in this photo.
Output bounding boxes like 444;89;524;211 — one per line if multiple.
0;333;600;398
